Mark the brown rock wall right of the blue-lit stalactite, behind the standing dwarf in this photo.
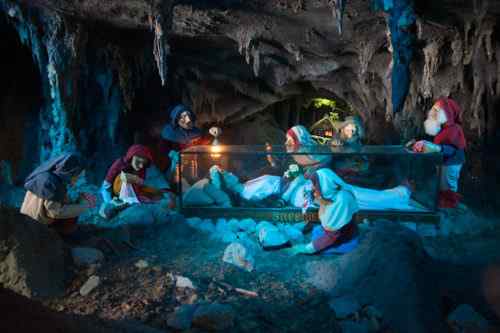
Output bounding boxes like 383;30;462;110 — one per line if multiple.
398;1;500;149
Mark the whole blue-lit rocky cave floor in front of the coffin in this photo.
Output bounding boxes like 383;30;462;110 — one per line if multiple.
0;183;500;332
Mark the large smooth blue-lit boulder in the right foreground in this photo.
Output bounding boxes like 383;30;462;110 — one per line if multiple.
306;221;446;333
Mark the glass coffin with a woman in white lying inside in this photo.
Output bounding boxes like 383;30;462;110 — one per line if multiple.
179;145;442;221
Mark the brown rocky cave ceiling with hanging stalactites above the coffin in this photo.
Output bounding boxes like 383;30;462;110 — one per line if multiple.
5;0;500;143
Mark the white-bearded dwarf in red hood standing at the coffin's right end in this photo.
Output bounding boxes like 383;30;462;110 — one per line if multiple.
413;98;467;208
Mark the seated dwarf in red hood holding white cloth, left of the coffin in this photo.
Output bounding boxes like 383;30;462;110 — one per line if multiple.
99;145;174;218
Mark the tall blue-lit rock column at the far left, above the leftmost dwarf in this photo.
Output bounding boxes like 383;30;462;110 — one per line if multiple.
3;2;86;160
